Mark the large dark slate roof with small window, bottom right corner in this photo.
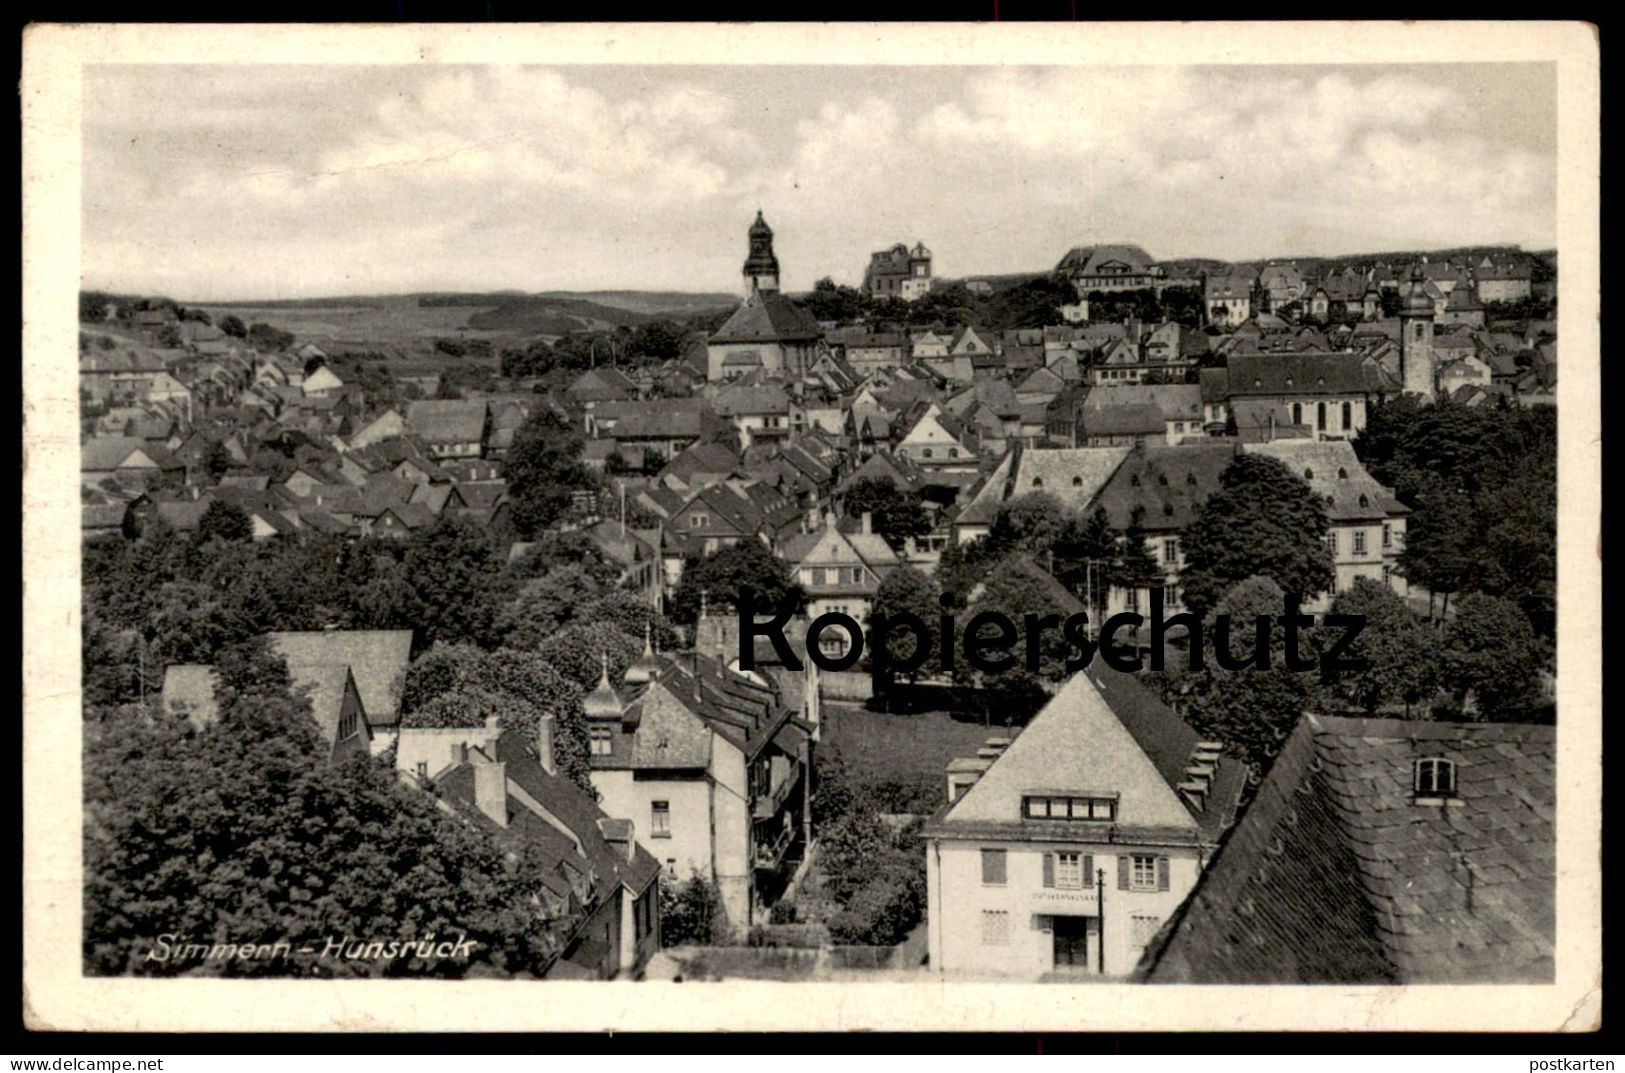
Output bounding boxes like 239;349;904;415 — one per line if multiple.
1141;714;1557;984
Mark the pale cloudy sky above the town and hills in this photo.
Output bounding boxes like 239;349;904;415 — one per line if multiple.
81;63;1557;301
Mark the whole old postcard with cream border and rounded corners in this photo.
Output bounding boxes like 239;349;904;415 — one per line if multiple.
24;23;1602;1031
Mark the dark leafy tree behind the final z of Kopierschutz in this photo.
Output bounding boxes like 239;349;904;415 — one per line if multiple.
1324;577;1438;719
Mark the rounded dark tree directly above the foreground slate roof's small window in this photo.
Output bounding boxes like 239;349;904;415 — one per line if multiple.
1443;593;1542;722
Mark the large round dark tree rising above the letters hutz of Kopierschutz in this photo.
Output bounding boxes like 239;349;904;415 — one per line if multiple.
1180;454;1334;615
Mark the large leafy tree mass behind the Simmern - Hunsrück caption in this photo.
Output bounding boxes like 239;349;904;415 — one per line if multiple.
83;654;580;977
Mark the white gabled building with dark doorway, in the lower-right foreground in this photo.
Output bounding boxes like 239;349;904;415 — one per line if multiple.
923;665;1246;980
